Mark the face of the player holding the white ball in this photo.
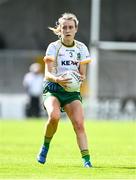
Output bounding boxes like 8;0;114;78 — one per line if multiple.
60;20;77;44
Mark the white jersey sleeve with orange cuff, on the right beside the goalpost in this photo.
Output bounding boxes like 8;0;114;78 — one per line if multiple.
80;44;91;64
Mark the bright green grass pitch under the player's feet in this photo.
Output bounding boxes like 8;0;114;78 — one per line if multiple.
0;119;136;180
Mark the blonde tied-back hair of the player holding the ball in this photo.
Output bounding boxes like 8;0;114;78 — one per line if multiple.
49;13;79;36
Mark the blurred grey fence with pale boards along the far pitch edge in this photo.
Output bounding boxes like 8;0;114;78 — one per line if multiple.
0;48;136;119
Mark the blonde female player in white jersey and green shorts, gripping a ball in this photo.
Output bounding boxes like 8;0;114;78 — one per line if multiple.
37;13;92;167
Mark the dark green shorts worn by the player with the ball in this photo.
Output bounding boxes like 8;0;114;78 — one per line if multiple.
43;83;82;108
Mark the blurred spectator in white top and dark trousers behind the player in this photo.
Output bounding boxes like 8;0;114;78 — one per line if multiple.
23;63;43;117
